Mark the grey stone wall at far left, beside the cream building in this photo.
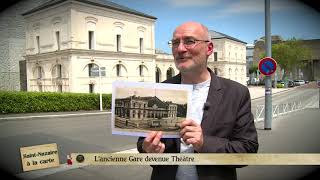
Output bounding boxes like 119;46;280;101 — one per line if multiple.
0;0;49;91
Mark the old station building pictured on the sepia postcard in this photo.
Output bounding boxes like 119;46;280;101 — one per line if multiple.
114;95;179;129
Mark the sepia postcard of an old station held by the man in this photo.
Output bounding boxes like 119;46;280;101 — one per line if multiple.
111;81;192;138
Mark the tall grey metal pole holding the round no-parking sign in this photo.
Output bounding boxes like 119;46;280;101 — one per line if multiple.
264;0;272;130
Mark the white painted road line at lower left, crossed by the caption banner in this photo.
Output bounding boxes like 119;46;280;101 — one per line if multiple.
15;148;139;179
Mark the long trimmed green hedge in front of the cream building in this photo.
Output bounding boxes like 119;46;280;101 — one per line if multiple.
0;91;111;114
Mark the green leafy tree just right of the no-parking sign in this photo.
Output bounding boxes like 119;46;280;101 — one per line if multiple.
260;38;311;79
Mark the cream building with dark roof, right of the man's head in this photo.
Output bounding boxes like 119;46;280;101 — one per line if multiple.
208;30;247;85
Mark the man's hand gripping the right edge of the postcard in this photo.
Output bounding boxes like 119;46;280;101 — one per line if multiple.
180;119;203;152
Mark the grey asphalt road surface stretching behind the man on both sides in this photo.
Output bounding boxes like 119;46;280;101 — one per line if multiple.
0;86;320;180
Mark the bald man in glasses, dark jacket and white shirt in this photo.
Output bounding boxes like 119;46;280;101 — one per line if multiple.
137;22;259;180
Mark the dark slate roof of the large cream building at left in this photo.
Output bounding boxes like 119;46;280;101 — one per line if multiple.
22;0;157;20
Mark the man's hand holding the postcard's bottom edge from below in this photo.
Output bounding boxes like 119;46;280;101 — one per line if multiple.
142;131;165;153
